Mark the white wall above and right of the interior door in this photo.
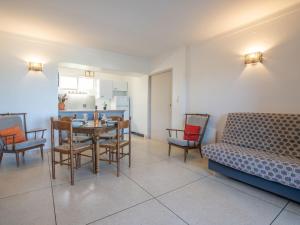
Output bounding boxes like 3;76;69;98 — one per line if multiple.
151;47;187;128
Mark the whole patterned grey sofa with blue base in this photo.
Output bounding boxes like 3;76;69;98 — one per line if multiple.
203;113;300;202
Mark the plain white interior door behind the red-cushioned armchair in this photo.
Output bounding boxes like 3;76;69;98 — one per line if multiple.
150;71;172;141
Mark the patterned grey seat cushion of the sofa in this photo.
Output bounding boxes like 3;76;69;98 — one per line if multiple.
202;143;300;189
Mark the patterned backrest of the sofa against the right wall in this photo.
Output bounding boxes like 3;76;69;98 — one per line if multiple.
222;113;300;158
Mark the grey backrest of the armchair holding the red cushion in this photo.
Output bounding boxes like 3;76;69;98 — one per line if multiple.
185;113;209;143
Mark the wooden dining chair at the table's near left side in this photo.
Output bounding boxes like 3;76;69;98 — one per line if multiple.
51;118;94;185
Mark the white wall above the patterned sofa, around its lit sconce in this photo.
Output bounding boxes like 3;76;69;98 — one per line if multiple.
187;8;300;141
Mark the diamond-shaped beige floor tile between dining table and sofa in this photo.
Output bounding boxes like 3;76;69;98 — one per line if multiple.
124;161;203;196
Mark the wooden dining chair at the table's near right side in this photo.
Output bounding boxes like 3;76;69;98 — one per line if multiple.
99;120;131;176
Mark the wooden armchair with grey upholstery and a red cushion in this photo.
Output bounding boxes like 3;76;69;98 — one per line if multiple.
167;113;209;162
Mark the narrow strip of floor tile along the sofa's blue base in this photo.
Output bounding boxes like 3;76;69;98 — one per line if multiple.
211;173;288;207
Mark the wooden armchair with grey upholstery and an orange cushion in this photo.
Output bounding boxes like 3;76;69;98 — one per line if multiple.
0;113;46;167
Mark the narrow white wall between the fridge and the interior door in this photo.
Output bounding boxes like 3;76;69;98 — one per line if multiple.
128;75;149;137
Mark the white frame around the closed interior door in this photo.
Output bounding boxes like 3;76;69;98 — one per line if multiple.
147;68;173;139
